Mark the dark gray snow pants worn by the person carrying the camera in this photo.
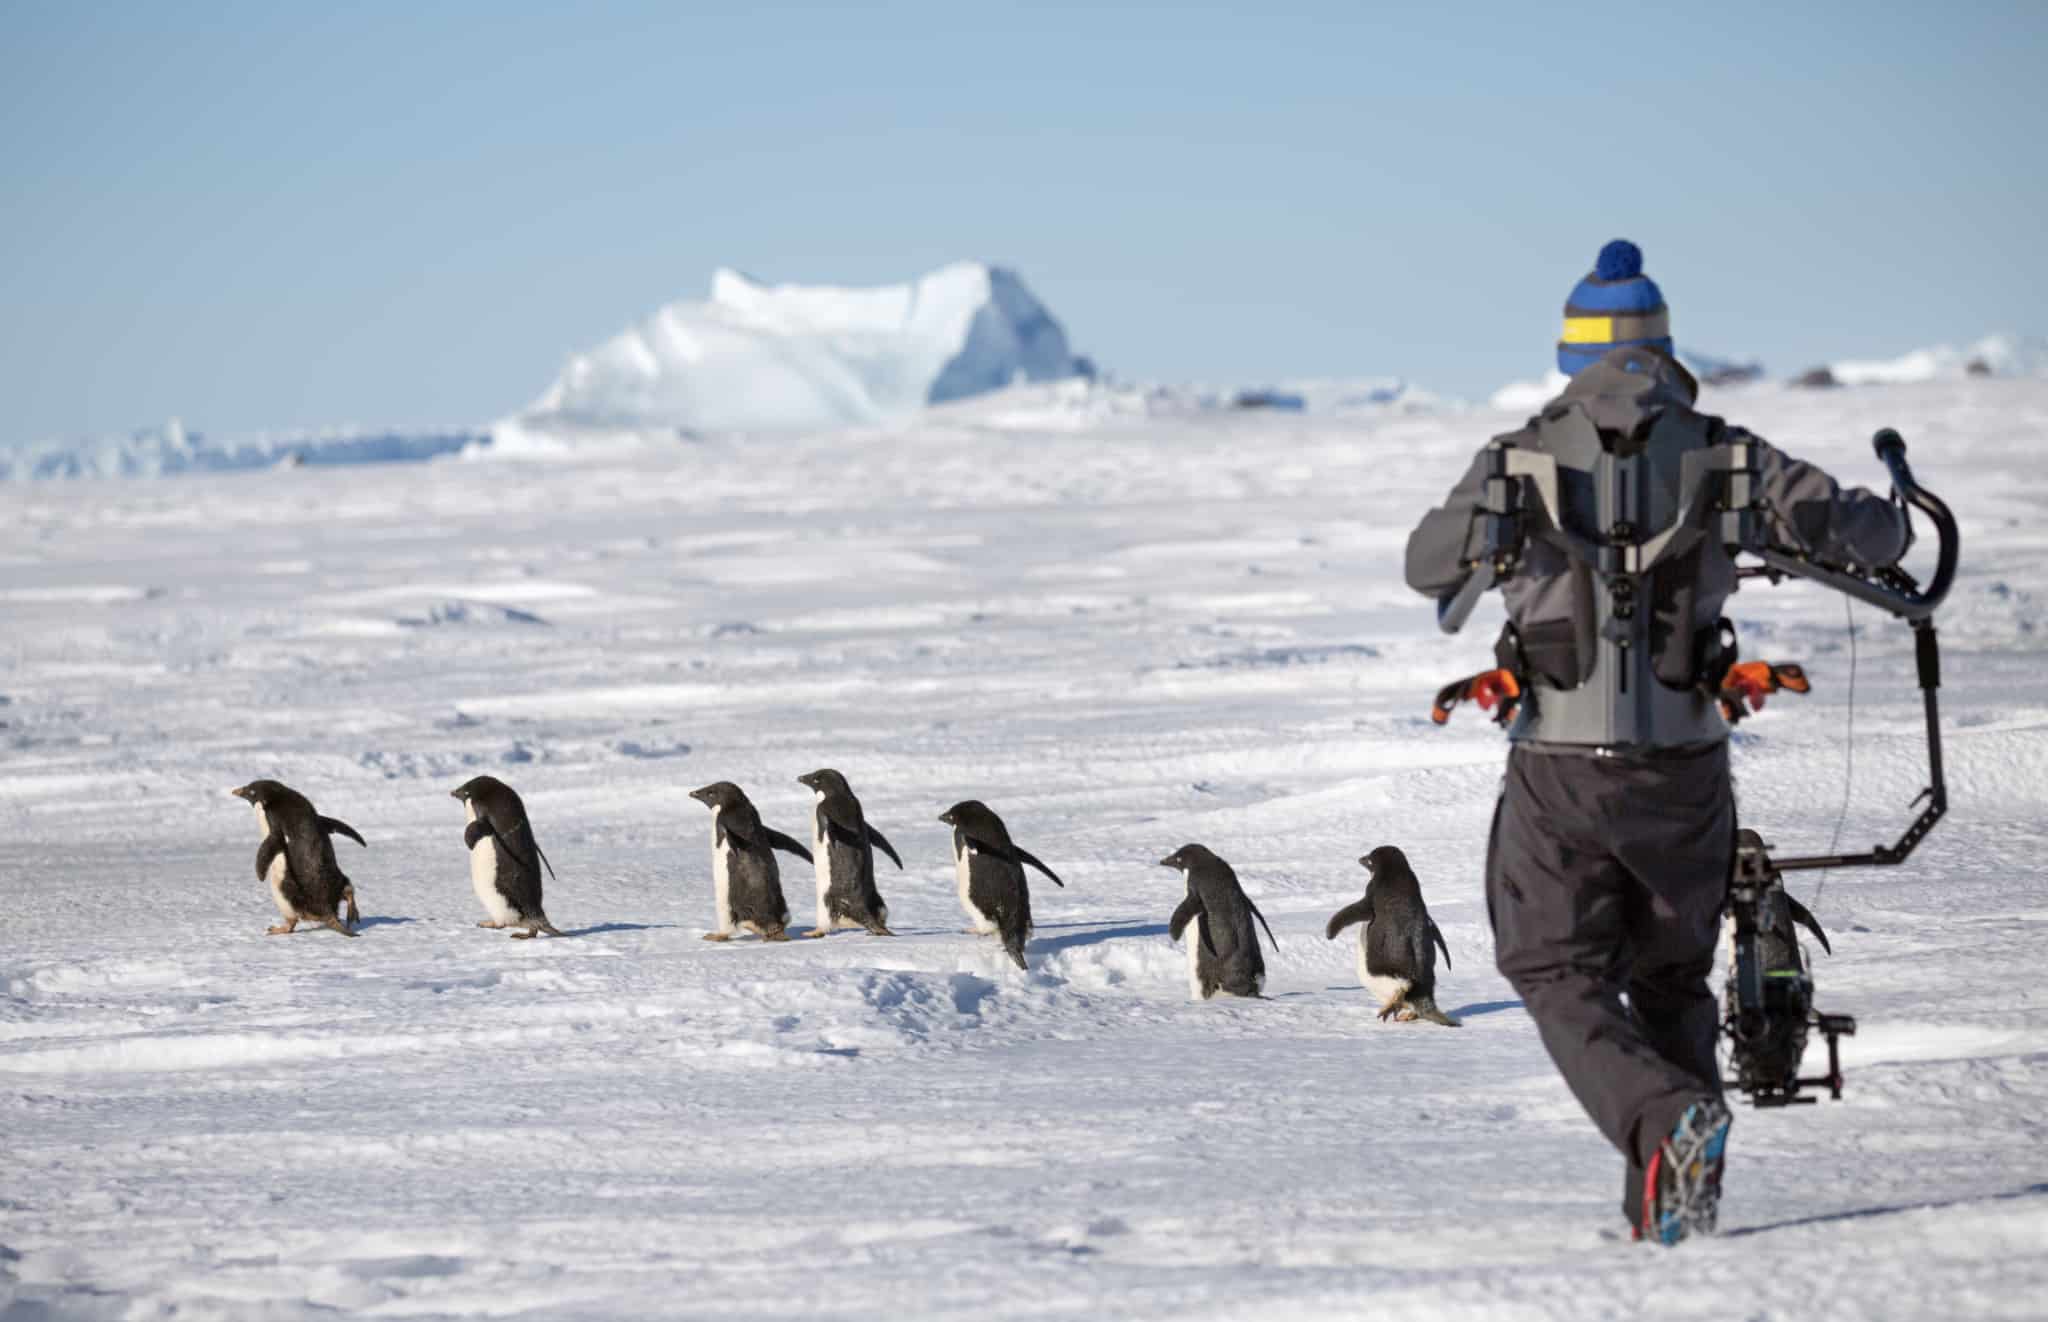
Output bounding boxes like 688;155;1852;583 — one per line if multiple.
1487;743;1735;1224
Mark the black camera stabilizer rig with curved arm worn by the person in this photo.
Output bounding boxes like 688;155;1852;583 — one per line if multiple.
1438;428;1958;1107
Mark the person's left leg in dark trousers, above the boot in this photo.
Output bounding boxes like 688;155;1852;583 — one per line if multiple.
1487;749;1718;1158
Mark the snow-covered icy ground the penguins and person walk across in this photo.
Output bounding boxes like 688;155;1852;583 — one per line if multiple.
0;381;2048;1322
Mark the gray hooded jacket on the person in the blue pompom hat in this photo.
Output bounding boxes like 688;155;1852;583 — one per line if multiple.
1407;348;1909;747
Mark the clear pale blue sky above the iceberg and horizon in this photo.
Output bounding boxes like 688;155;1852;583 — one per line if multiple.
0;2;2048;442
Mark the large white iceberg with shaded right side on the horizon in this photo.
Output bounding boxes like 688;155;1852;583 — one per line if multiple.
500;262;1090;442
